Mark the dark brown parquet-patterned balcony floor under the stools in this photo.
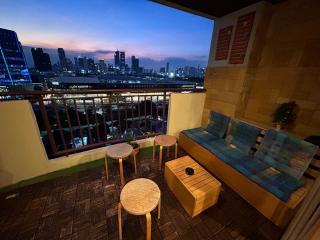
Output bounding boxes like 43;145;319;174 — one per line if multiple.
0;149;281;240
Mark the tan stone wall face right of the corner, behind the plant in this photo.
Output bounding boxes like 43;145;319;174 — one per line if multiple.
240;0;320;137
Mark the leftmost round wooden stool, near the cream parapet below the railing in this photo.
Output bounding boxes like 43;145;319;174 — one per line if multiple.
105;143;137;187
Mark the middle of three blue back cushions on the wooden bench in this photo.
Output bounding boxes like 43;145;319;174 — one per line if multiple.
228;120;260;154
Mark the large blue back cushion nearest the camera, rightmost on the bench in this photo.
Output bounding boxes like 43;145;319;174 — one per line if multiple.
255;129;318;180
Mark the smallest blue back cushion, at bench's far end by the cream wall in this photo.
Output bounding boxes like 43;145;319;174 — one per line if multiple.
206;112;230;138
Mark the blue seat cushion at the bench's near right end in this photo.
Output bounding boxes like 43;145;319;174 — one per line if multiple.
249;167;304;202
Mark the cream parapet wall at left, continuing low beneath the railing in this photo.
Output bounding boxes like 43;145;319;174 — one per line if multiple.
0;101;152;188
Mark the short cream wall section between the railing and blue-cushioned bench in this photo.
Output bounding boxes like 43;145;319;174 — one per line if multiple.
167;93;205;137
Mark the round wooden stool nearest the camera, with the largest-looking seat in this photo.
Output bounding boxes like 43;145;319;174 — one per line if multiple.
118;178;161;240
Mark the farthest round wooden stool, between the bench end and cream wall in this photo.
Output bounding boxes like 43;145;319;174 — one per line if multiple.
153;135;178;169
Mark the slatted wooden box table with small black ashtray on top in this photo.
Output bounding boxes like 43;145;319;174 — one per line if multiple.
164;156;221;217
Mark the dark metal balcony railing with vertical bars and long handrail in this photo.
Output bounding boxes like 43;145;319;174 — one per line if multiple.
0;88;205;158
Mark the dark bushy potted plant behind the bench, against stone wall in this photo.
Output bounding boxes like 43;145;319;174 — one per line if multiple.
272;101;299;130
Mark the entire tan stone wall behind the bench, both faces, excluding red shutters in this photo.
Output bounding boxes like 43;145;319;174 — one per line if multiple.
203;0;320;137
